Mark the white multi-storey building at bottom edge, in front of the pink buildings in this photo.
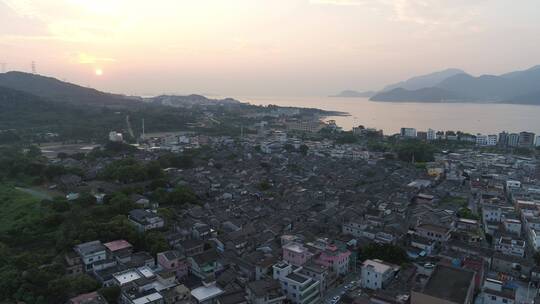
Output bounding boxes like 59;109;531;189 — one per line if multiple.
273;262;321;304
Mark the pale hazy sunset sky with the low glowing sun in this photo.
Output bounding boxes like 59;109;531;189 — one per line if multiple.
0;0;540;97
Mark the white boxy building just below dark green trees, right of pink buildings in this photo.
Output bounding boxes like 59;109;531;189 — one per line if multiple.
360;260;399;290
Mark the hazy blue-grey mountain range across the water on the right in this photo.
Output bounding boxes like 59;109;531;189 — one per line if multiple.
371;66;540;105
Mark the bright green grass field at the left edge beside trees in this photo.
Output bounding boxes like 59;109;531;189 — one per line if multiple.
0;183;40;233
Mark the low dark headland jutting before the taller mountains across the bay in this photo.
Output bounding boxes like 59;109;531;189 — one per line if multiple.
370;88;460;102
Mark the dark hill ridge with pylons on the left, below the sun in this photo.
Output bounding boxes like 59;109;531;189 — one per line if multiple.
0;72;134;106
